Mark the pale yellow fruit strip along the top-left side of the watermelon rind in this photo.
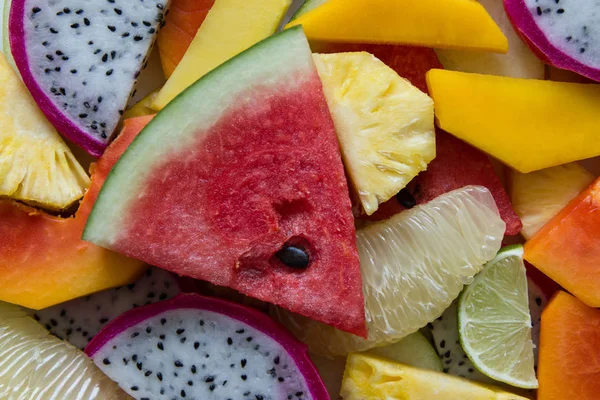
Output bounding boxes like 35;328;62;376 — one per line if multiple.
152;0;292;111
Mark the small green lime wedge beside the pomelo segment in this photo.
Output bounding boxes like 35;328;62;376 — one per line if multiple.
458;245;538;389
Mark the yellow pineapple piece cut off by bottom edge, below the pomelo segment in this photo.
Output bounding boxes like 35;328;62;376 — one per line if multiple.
340;354;528;400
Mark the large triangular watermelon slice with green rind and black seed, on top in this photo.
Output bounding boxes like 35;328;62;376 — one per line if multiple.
84;29;367;336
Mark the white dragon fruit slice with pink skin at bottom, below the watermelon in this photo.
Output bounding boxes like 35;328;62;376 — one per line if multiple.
85;294;329;400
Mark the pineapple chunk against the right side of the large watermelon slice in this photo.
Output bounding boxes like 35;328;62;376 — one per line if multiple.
313;52;435;215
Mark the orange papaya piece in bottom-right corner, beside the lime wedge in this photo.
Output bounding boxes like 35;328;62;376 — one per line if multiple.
538;291;600;400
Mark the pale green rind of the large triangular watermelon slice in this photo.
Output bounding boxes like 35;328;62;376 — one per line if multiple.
83;28;314;248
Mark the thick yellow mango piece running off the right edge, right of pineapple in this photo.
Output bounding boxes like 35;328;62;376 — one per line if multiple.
427;69;600;173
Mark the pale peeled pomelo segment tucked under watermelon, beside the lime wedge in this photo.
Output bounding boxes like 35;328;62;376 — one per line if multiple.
274;186;505;355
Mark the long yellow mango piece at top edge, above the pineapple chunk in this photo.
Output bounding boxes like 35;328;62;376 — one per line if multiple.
288;0;508;53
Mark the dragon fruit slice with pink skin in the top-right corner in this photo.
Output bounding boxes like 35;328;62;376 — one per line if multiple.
503;0;600;81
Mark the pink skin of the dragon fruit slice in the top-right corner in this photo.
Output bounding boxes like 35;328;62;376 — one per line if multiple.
503;0;600;81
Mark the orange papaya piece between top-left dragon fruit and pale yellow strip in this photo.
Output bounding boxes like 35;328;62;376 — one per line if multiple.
156;0;215;79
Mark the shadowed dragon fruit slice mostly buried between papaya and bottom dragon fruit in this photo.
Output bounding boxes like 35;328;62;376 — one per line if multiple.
33;268;180;350
